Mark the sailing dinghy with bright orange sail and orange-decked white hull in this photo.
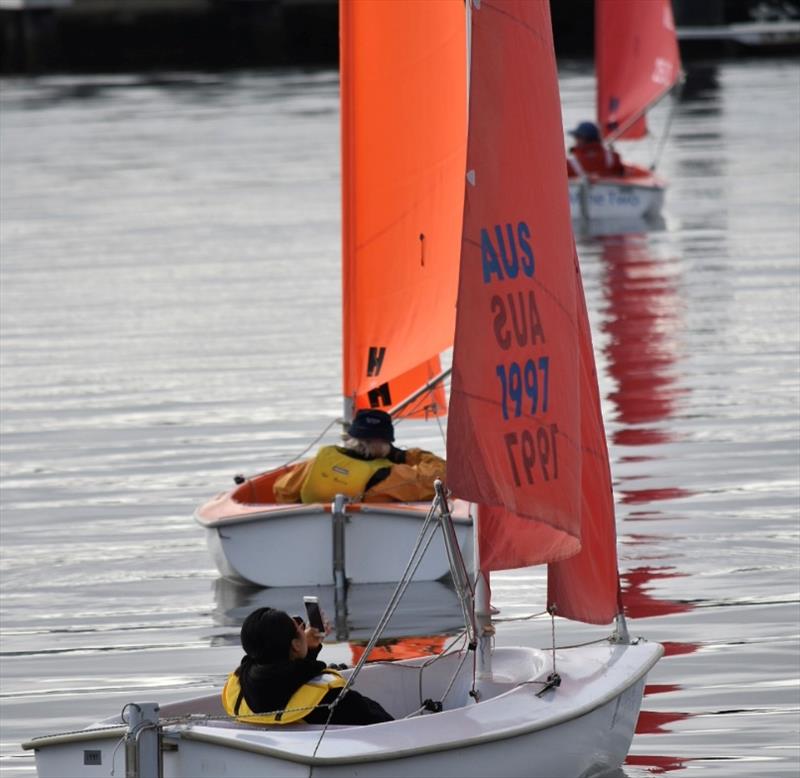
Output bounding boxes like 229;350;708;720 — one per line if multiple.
194;3;471;587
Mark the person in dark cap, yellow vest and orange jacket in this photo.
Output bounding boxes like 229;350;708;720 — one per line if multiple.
273;409;446;503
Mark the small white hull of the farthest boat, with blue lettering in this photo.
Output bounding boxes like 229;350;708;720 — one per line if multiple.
569;174;666;220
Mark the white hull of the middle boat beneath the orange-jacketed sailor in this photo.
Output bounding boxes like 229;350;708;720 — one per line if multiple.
195;503;472;587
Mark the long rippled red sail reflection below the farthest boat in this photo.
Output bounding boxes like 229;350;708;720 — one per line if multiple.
596;232;698;775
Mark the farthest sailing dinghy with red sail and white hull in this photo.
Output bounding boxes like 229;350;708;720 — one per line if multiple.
569;0;682;219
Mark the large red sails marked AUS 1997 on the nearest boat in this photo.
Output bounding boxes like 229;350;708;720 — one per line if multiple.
447;0;618;623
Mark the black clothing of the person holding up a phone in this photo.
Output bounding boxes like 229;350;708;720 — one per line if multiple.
236;646;393;724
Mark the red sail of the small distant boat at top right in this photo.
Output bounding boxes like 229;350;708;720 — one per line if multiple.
595;0;681;140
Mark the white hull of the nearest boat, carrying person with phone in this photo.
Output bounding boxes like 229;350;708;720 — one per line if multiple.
24;643;663;778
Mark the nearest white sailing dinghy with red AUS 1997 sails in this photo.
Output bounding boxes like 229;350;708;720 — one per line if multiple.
24;0;662;778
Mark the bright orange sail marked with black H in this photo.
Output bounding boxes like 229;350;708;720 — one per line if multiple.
340;0;466;412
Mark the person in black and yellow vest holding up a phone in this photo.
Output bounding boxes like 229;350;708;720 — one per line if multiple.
222;607;393;724
